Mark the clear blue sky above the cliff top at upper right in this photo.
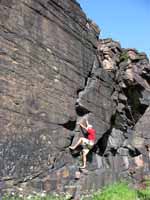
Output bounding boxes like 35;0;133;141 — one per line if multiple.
77;0;150;58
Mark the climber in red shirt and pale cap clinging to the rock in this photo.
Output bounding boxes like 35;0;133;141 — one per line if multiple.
69;121;96;169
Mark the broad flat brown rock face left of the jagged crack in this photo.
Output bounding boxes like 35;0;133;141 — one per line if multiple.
0;1;96;176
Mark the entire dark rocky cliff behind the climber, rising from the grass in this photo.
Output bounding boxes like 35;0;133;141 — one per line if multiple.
0;0;150;196
